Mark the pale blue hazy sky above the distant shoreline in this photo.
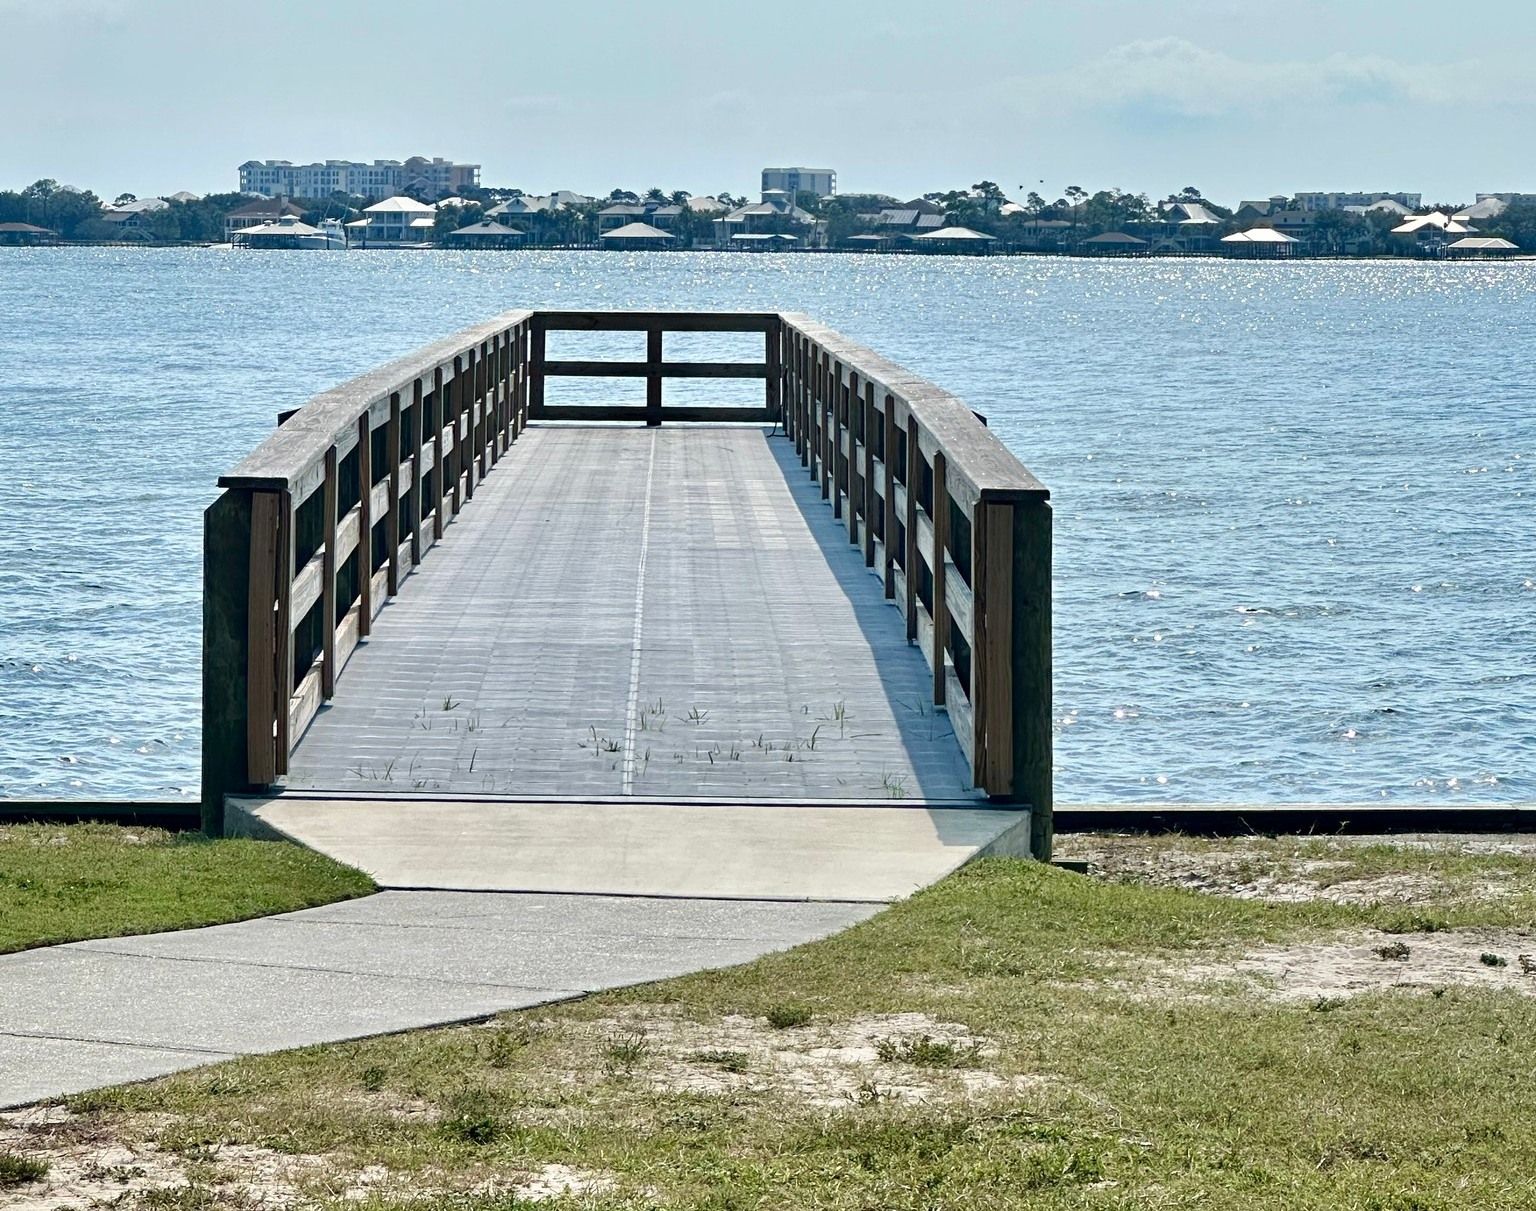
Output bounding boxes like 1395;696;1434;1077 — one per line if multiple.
0;0;1536;204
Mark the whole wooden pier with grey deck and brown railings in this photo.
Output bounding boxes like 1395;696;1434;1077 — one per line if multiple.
203;310;1052;858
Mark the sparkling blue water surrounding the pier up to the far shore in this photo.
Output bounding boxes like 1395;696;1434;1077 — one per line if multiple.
0;249;1536;804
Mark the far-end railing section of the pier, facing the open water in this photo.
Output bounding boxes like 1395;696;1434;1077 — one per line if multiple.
528;310;782;426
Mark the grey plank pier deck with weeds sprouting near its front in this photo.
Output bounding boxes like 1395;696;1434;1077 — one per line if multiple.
287;426;980;801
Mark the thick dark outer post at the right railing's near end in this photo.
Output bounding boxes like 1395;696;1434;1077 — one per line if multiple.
1012;499;1055;862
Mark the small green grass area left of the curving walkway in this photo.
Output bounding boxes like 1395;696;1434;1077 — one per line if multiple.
0;824;375;953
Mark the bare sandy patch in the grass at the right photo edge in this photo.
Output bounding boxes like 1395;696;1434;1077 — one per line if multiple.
1127;930;1536;1002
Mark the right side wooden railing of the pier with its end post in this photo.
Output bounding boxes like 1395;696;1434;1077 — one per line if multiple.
780;315;1052;856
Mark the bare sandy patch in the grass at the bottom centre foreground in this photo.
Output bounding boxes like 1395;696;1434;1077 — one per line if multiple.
587;1008;1044;1106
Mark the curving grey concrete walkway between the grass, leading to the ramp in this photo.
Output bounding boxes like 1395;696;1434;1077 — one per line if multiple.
0;891;880;1108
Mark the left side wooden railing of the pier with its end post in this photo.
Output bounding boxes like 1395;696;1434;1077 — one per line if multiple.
203;310;533;833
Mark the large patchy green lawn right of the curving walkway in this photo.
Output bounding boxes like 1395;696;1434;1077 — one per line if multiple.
33;847;1536;1211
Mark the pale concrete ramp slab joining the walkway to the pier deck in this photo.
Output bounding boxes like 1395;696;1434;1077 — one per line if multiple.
226;795;1029;902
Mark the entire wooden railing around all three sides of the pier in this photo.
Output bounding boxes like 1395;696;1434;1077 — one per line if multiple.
203;310;1052;856
